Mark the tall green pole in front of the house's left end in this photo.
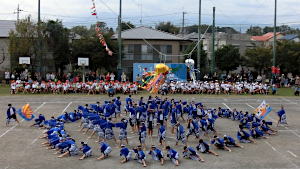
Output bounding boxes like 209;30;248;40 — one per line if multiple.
118;0;122;81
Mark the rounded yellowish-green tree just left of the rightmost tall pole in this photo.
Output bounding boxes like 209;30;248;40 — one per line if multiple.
244;46;272;74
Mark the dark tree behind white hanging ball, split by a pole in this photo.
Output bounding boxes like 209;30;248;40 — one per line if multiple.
183;42;208;72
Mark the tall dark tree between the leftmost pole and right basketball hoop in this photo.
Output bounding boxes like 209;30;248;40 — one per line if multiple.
45;20;70;72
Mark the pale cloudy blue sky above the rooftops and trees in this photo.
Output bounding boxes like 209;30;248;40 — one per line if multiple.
0;0;300;33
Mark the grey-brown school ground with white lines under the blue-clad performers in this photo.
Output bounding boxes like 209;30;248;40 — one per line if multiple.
0;95;300;169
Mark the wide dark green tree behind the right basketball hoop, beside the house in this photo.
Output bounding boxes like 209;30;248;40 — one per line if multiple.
71;33;118;71
